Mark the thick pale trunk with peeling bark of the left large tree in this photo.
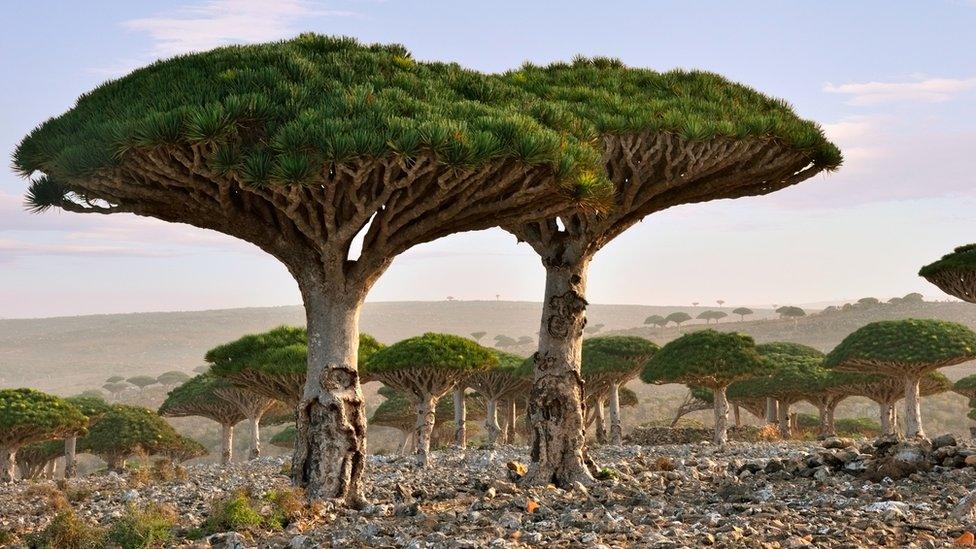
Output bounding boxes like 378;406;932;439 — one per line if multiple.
292;292;366;507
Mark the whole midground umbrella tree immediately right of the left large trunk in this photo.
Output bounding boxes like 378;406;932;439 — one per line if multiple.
364;333;498;467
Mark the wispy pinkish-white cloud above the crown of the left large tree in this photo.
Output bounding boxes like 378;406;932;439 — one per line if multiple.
123;0;356;57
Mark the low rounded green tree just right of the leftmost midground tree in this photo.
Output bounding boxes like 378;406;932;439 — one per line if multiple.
78;404;180;471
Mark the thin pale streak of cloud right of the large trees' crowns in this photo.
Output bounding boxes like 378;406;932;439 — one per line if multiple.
823;77;976;106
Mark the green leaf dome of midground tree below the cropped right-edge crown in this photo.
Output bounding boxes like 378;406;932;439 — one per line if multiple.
824;319;976;369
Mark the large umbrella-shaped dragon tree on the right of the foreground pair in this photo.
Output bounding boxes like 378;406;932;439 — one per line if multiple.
501;58;841;486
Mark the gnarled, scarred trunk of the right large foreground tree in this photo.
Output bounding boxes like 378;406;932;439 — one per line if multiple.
524;258;593;488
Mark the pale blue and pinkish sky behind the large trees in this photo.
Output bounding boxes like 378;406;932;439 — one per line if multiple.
0;0;976;318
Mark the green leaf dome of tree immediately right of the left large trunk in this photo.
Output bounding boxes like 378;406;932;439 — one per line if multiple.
363;332;498;375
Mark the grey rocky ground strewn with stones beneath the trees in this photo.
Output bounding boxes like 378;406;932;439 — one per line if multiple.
0;439;976;548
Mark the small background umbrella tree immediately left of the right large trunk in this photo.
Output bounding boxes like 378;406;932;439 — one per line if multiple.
468;350;532;448
